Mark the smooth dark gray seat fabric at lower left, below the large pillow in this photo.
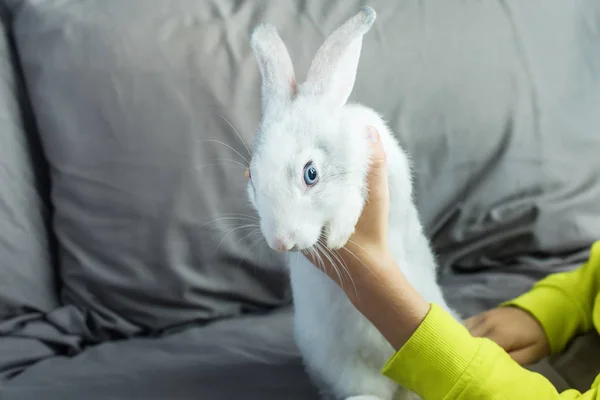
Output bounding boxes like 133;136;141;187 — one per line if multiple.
0;309;318;400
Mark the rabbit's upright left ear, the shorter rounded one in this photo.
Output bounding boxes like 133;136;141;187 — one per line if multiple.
250;24;296;115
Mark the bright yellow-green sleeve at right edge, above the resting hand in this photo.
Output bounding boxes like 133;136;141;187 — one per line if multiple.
505;241;600;353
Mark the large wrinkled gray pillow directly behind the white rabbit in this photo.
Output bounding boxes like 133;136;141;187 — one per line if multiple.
15;0;600;333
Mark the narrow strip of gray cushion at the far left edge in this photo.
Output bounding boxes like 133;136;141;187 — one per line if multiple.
0;10;58;322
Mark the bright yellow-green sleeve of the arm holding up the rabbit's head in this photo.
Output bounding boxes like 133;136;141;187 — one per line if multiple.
383;305;600;400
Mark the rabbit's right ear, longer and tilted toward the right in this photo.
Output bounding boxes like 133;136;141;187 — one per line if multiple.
301;7;376;107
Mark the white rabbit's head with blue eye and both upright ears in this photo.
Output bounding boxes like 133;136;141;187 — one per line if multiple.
247;7;375;251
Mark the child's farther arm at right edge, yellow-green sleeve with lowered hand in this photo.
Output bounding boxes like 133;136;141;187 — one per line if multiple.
465;242;600;365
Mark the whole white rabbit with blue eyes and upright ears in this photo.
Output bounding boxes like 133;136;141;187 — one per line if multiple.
248;7;462;400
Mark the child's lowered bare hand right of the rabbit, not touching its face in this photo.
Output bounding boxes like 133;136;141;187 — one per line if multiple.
465;307;550;365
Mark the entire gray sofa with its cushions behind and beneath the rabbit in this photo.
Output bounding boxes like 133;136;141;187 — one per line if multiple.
0;0;600;400
